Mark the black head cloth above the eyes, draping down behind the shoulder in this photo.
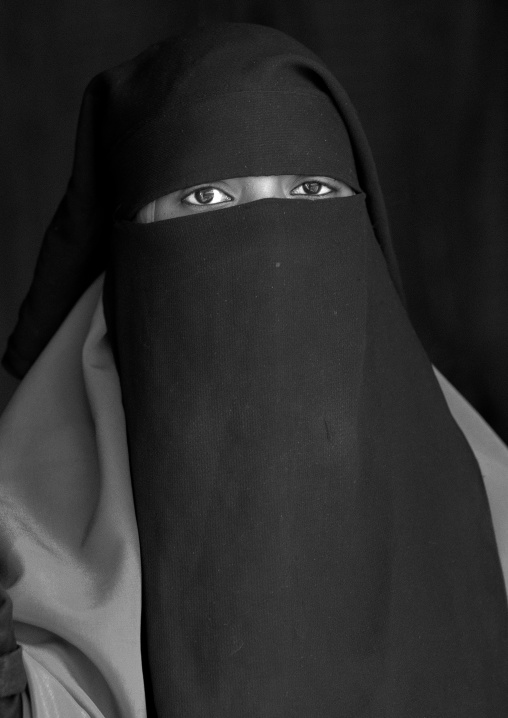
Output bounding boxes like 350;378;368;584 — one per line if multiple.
3;23;401;377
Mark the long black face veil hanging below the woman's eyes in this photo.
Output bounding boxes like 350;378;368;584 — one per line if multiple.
108;190;508;718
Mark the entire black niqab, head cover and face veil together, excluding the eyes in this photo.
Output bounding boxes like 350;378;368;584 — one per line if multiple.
3;24;508;718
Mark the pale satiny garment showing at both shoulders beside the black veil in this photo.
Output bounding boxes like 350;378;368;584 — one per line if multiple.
0;280;508;718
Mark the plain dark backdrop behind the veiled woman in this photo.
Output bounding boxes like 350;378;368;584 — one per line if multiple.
0;0;508;441
